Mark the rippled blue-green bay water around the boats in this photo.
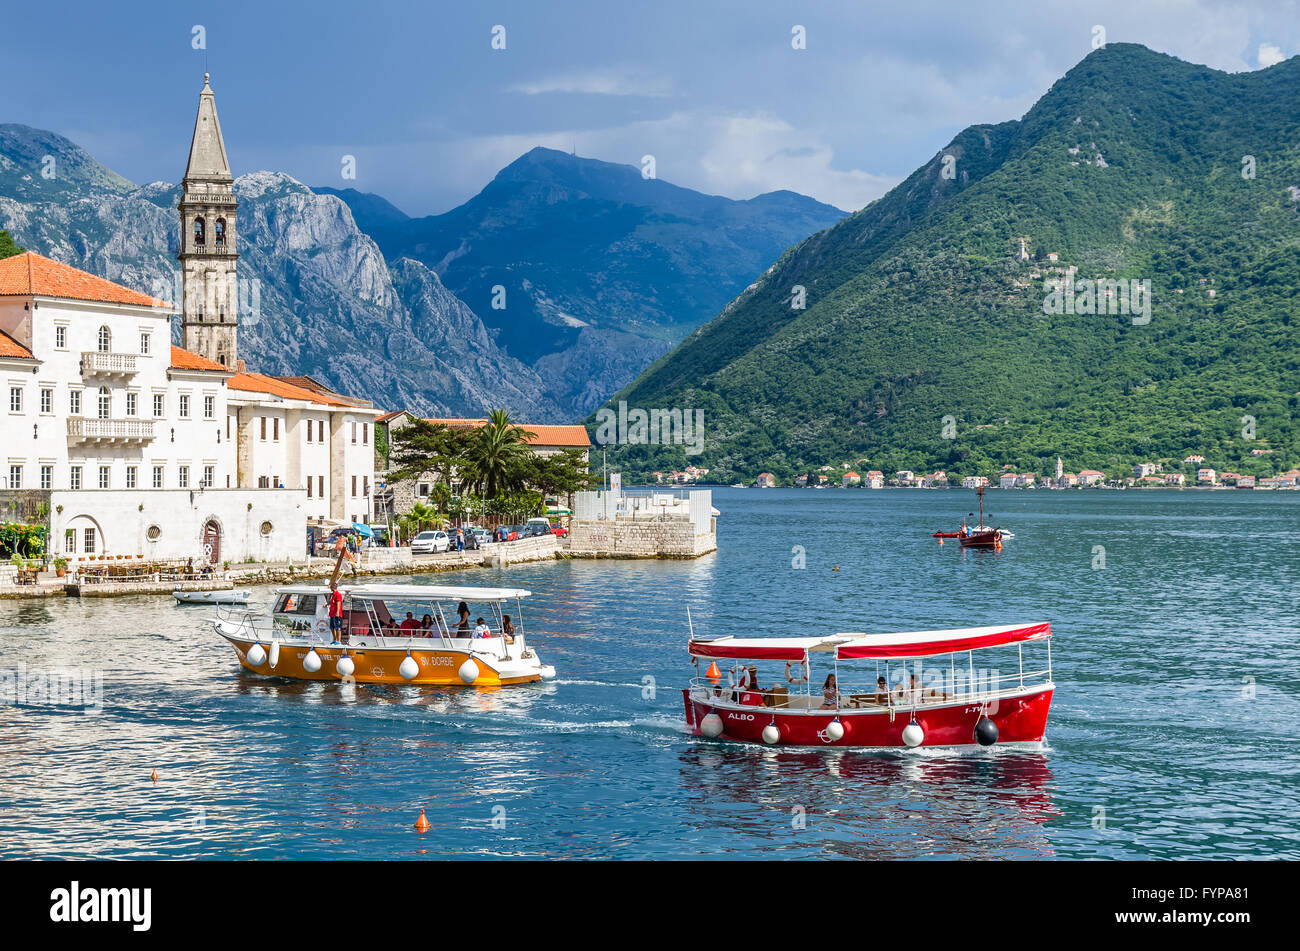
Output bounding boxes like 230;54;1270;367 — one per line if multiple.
0;490;1300;859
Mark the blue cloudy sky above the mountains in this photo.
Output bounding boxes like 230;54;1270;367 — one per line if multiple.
0;0;1300;214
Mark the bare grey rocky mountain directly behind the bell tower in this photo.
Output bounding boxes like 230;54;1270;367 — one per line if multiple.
0;125;569;422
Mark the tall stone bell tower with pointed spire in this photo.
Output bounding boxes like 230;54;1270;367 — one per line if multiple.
177;73;239;369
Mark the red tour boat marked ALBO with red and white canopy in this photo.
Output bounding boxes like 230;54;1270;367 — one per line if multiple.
683;622;1056;747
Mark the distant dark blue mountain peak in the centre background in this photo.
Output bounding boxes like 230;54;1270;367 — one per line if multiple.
325;148;844;417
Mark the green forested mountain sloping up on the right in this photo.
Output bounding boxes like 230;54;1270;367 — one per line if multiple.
593;44;1300;481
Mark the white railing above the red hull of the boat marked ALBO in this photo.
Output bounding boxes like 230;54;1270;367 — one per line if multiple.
690;669;1052;711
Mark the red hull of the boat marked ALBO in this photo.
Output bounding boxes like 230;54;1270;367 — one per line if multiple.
683;686;1054;748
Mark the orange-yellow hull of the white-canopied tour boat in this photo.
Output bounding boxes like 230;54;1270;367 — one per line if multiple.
219;635;554;687
